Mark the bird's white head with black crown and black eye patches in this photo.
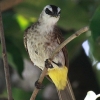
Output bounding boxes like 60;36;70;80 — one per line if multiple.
39;5;61;24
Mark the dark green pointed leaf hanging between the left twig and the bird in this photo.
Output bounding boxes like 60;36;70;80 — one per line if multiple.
6;38;24;76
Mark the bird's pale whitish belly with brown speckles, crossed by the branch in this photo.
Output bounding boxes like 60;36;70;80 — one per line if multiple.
27;32;65;70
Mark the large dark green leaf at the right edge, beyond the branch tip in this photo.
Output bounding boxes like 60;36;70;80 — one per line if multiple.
89;6;100;61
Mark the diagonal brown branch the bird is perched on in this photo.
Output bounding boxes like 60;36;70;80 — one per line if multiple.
30;26;89;100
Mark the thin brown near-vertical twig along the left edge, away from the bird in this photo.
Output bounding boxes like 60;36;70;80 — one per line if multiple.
0;9;13;100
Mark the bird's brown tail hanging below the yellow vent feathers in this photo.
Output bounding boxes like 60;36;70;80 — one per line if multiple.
57;79;75;100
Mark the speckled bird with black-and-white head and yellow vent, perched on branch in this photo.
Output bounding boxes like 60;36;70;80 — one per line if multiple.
24;5;75;100
